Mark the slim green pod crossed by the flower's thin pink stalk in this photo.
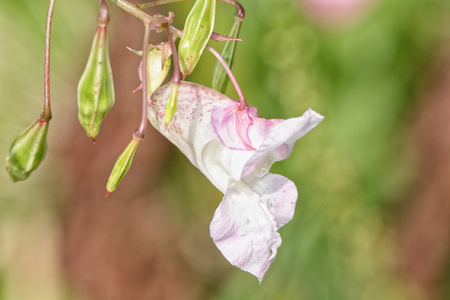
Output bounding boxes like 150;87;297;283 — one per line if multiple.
212;17;242;94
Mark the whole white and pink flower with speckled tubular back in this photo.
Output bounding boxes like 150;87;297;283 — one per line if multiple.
148;82;323;281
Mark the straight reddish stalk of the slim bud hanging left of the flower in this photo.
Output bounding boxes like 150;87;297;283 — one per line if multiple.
134;24;150;138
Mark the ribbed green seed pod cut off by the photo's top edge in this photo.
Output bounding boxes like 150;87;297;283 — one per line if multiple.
178;0;216;75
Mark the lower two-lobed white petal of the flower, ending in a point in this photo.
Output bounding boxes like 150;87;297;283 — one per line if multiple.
210;174;297;281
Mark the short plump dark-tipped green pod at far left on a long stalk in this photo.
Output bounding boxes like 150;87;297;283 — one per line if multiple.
6;119;49;182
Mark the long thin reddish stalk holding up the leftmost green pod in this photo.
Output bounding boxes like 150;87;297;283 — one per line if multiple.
41;0;55;122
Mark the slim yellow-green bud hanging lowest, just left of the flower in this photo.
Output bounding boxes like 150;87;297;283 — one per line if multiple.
106;135;141;196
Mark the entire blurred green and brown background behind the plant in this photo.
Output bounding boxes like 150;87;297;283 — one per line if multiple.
0;0;450;300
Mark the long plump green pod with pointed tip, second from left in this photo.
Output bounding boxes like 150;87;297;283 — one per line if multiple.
78;24;115;140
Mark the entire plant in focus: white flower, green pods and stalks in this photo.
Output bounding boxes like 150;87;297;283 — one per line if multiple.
6;0;323;281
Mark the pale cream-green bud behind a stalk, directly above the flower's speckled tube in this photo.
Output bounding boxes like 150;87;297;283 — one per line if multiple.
135;43;172;97
